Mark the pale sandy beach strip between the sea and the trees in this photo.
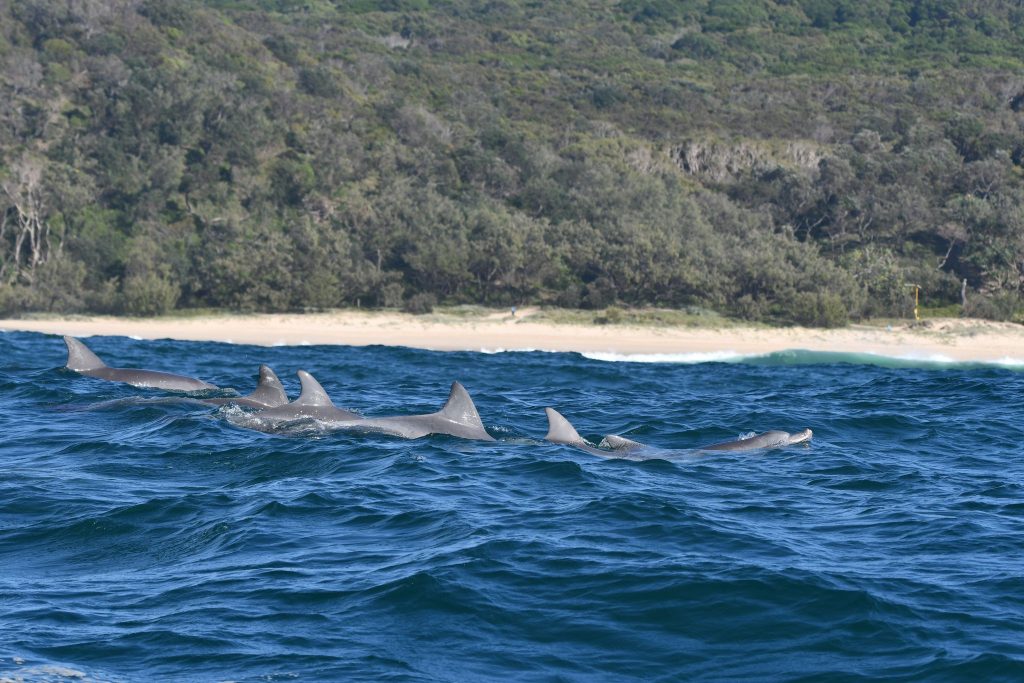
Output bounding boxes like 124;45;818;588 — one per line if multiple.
0;308;1024;362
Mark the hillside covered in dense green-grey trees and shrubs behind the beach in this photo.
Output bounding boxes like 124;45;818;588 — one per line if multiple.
0;0;1024;325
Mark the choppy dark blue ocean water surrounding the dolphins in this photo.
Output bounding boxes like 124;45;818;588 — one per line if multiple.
0;333;1024;681
